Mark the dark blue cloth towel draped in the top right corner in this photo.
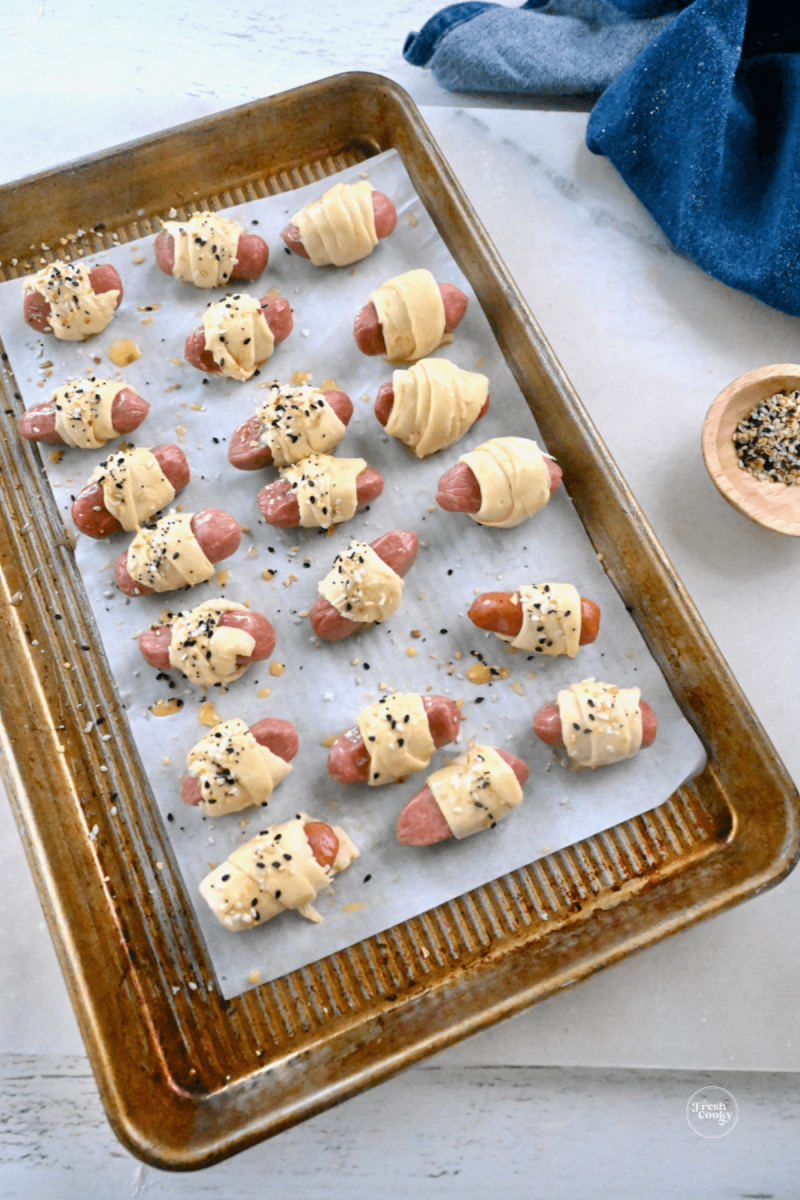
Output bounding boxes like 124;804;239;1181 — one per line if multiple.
587;0;800;316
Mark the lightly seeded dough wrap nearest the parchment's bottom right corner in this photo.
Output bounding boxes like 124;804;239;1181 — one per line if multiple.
558;679;642;769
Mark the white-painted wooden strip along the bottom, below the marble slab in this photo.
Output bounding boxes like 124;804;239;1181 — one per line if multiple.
0;1055;800;1200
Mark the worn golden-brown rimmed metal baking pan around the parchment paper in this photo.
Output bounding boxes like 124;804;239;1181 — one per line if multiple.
0;73;799;1169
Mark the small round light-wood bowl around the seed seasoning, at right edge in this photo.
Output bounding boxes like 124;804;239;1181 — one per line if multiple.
703;362;800;538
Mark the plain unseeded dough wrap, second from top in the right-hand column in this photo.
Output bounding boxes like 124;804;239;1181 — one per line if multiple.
369;268;452;362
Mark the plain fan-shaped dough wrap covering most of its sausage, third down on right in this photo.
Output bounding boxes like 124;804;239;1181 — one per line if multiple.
386;359;489;458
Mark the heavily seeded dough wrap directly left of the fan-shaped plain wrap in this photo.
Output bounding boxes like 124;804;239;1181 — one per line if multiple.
255;383;345;467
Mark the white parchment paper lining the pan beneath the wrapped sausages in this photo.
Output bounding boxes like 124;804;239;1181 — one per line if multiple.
0;151;704;997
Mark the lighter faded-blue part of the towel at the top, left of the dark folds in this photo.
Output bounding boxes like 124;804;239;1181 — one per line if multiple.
403;0;686;96
